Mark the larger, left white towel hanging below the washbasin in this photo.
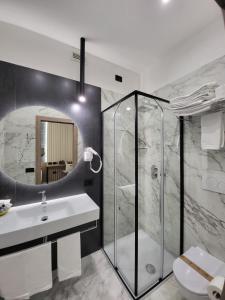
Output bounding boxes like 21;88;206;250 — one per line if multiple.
0;243;52;300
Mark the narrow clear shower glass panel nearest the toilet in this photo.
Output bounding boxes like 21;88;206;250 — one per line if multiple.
163;107;182;277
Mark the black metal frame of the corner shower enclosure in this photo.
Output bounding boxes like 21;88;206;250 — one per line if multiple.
102;90;184;300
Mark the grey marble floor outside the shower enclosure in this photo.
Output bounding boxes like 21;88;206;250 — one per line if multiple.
31;251;185;300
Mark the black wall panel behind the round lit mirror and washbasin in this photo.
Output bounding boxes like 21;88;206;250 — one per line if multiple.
0;62;102;256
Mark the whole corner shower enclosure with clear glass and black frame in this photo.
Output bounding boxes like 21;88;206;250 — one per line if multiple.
103;91;182;298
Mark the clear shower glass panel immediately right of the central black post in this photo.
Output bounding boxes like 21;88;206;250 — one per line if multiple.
138;97;164;294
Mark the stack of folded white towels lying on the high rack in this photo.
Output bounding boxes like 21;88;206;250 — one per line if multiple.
170;82;221;116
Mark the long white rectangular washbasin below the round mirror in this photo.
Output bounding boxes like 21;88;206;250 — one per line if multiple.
0;194;99;249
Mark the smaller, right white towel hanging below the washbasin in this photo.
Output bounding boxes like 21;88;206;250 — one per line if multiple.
57;232;81;281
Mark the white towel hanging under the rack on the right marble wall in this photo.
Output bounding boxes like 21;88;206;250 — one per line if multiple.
201;112;224;150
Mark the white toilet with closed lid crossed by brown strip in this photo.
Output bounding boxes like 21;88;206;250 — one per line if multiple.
173;247;225;300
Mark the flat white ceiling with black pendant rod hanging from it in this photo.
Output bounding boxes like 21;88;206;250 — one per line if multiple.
0;0;221;71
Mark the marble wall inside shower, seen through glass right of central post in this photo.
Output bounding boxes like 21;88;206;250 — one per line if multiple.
138;99;180;256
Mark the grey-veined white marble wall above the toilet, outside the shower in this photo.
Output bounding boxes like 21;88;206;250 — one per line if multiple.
155;56;225;261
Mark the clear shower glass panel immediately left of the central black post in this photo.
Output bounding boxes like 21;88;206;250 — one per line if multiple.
115;97;135;291
